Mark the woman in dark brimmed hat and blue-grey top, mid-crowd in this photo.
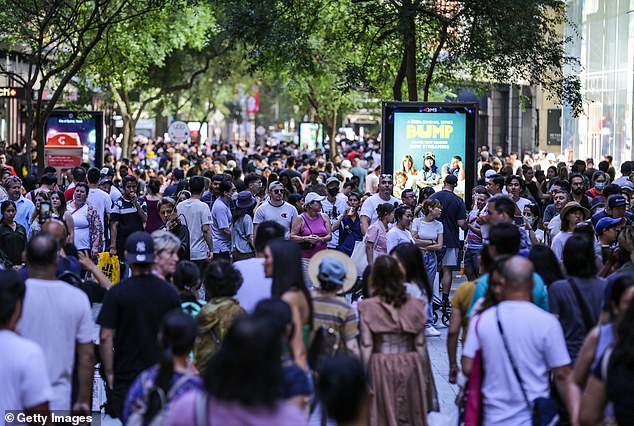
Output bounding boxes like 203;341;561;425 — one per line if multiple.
231;191;256;262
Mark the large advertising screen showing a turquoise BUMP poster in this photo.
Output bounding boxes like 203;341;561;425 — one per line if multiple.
382;102;477;205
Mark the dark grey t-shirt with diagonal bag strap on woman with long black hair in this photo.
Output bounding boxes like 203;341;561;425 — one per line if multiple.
548;277;607;362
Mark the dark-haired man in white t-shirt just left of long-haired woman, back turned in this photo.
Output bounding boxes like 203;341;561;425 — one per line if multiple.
233;221;285;313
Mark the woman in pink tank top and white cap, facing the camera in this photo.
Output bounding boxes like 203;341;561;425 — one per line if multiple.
291;192;332;285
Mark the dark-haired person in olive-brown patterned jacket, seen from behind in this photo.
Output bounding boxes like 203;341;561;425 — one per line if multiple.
194;259;245;371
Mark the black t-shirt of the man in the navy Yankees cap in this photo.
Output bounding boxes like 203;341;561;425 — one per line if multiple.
97;275;180;380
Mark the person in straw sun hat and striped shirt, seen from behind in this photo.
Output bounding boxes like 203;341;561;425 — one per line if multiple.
308;250;360;356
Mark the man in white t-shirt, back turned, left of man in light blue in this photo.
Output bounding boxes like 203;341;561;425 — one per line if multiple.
176;176;214;273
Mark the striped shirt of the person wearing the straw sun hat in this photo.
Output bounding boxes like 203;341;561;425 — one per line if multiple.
313;295;359;342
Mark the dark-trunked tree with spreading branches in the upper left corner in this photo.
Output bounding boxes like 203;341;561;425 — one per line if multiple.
0;0;167;175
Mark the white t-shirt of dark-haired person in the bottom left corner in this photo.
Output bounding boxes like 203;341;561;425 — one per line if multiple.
0;330;52;416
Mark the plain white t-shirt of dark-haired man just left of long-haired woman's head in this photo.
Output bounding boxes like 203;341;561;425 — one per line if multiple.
233;257;272;313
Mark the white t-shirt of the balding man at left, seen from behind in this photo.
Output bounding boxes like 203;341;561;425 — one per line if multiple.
17;278;95;410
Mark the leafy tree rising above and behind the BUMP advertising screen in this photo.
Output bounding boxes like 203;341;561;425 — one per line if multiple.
351;0;581;111
